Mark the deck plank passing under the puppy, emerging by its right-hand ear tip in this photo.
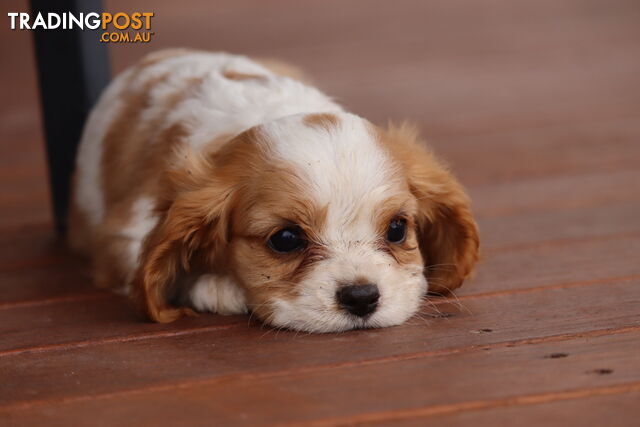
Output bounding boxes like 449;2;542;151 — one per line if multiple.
0;231;640;350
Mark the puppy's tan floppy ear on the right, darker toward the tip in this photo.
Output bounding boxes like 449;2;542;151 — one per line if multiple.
378;124;479;294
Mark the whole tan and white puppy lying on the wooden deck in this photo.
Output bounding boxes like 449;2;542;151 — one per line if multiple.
69;50;478;332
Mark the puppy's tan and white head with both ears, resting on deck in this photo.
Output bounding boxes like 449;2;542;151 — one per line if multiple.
134;113;478;332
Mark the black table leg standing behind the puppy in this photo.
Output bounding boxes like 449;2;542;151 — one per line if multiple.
30;0;109;232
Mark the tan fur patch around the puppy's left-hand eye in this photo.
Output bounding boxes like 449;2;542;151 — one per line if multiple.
185;128;327;319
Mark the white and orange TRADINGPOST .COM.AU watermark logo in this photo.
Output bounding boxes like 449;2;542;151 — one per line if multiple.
7;12;155;43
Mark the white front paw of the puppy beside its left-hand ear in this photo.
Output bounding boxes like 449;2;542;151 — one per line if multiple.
189;274;247;315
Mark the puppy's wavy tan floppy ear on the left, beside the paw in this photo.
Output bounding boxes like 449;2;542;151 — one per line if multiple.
132;152;232;322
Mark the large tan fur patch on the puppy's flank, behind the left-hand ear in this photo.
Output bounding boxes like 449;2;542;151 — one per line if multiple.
84;55;201;304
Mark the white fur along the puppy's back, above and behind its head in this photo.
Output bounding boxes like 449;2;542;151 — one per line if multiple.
75;51;342;226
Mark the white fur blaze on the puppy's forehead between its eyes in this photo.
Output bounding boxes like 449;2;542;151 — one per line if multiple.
263;113;403;237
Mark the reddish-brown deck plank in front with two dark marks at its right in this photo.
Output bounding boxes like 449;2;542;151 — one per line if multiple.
0;330;640;425
